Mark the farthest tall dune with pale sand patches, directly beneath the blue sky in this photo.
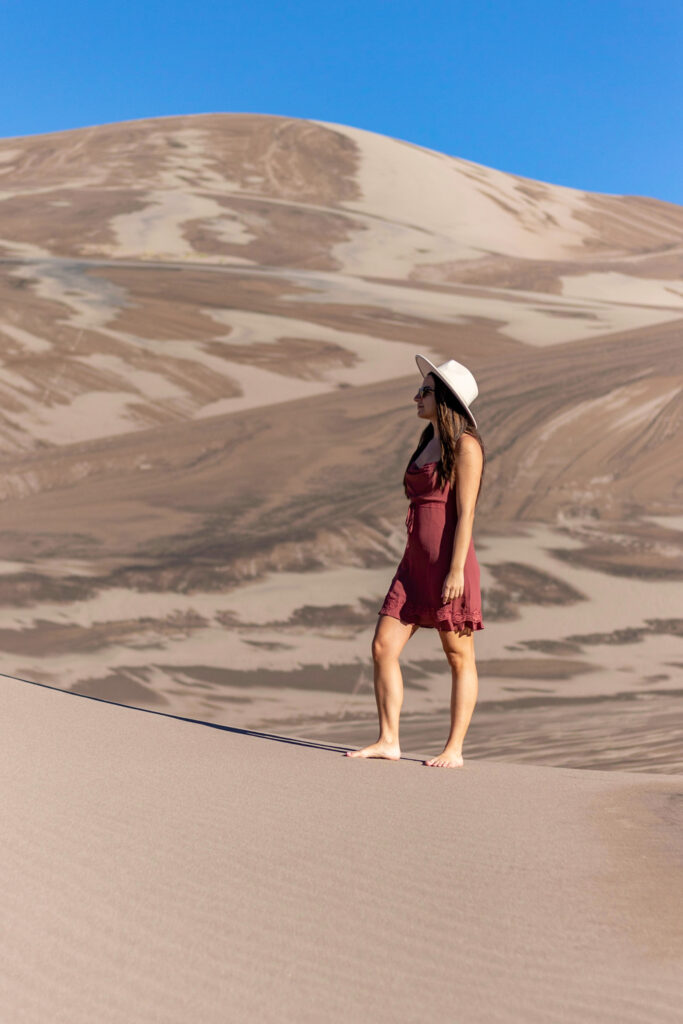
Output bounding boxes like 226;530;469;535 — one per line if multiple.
0;115;683;451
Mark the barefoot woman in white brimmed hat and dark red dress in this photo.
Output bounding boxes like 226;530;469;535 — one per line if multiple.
346;355;485;768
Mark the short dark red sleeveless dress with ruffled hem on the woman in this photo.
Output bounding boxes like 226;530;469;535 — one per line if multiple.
378;462;483;632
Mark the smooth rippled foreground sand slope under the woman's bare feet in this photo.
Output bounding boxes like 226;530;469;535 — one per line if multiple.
0;678;683;1024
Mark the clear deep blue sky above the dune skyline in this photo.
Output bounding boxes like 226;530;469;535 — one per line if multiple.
0;0;683;204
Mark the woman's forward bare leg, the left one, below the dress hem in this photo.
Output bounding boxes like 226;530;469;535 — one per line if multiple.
346;615;420;761
